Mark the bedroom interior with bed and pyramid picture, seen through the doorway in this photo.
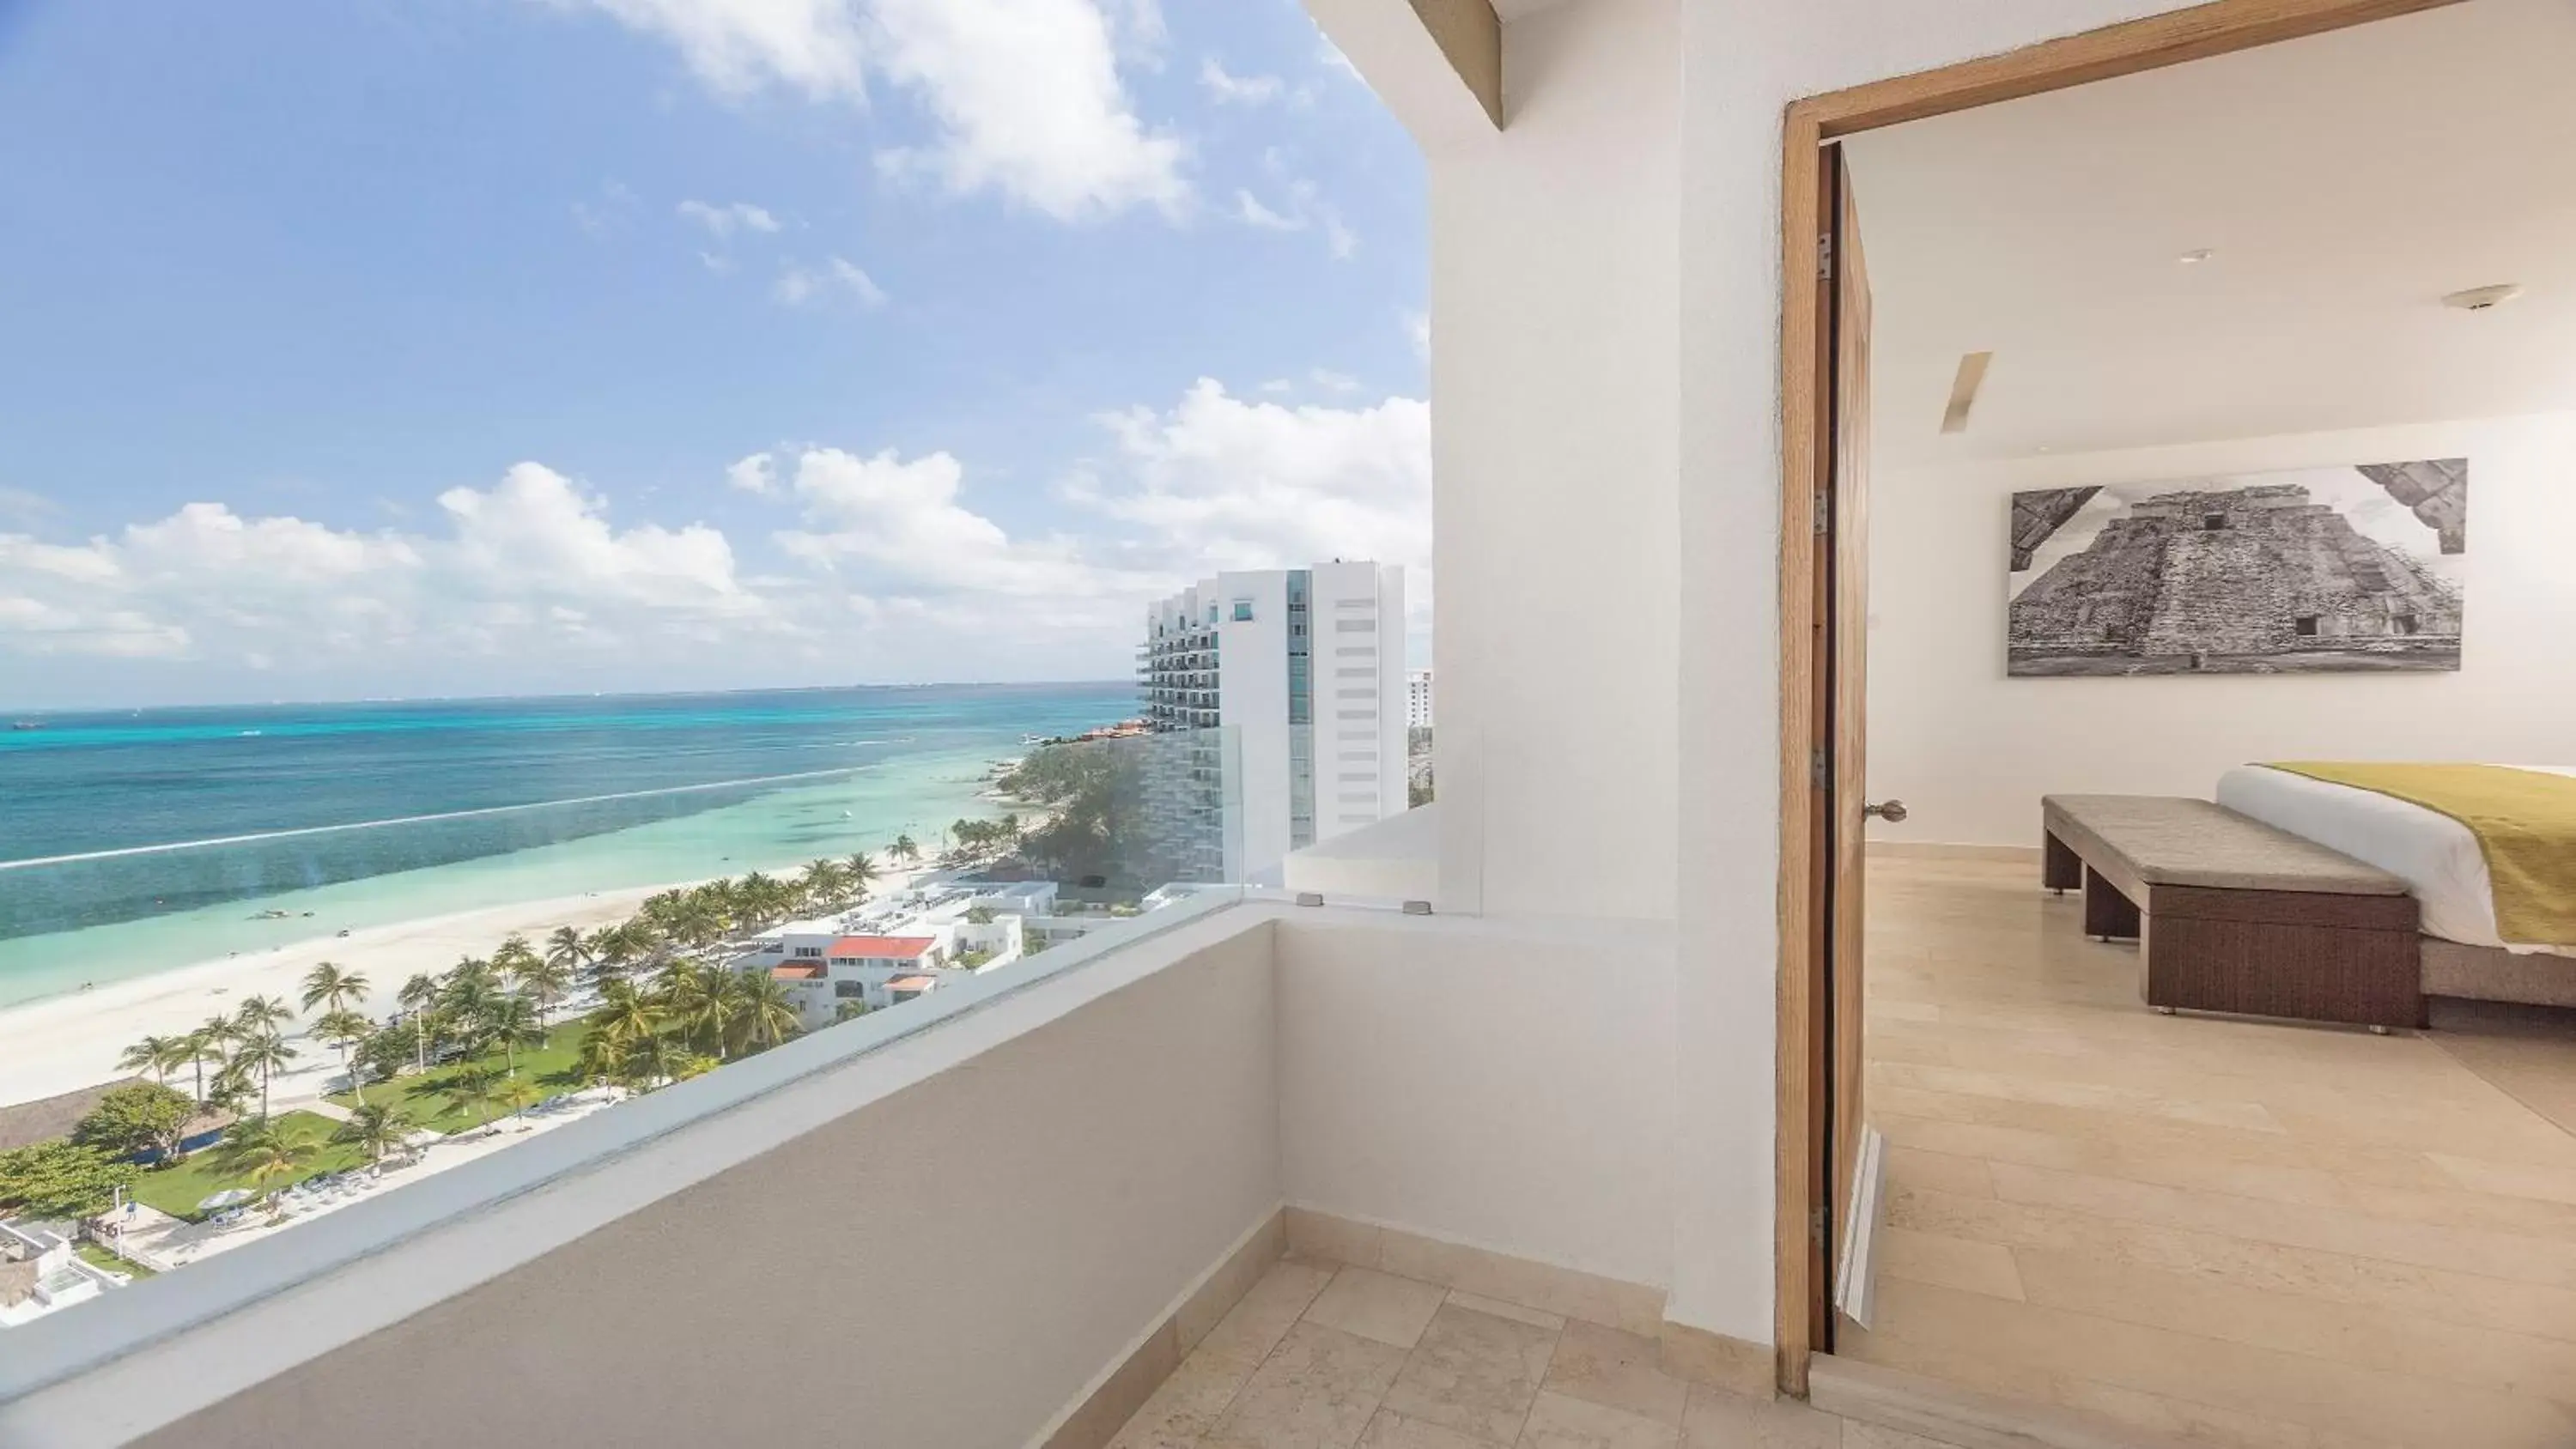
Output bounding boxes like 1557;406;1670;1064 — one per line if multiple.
1832;0;2576;1449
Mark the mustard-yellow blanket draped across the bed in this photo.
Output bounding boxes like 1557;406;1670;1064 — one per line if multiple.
2272;761;2576;944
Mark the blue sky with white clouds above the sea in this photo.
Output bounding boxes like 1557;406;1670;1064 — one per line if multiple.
0;0;1430;708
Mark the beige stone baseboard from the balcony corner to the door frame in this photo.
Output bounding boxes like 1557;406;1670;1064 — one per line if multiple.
1288;1207;1780;1397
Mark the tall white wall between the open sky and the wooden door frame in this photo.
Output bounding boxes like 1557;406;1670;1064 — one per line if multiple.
1311;0;2215;1341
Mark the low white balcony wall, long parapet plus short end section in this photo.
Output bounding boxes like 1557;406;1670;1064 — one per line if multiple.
35;903;1674;1449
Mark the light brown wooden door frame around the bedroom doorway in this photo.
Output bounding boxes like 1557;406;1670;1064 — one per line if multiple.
1772;0;2458;1395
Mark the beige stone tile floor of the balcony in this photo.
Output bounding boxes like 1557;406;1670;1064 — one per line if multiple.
1110;1256;1945;1449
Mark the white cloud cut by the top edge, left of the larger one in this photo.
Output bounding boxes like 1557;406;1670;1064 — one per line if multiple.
556;0;866;100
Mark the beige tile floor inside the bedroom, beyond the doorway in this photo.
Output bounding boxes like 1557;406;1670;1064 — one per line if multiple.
1842;857;2576;1449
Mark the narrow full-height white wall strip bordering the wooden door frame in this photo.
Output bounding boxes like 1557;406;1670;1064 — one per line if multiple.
1649;0;2174;1341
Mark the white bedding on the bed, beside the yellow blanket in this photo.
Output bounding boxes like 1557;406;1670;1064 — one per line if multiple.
2218;764;2576;955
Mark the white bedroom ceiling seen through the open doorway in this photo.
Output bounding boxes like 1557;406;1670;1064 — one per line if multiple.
1852;0;2576;469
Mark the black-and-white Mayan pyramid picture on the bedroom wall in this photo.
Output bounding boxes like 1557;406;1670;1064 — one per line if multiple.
2009;458;2468;675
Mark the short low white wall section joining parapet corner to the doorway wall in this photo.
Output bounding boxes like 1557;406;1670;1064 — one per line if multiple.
1275;911;1674;1287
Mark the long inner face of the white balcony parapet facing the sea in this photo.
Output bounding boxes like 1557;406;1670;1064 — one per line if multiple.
116;931;1280;1449
